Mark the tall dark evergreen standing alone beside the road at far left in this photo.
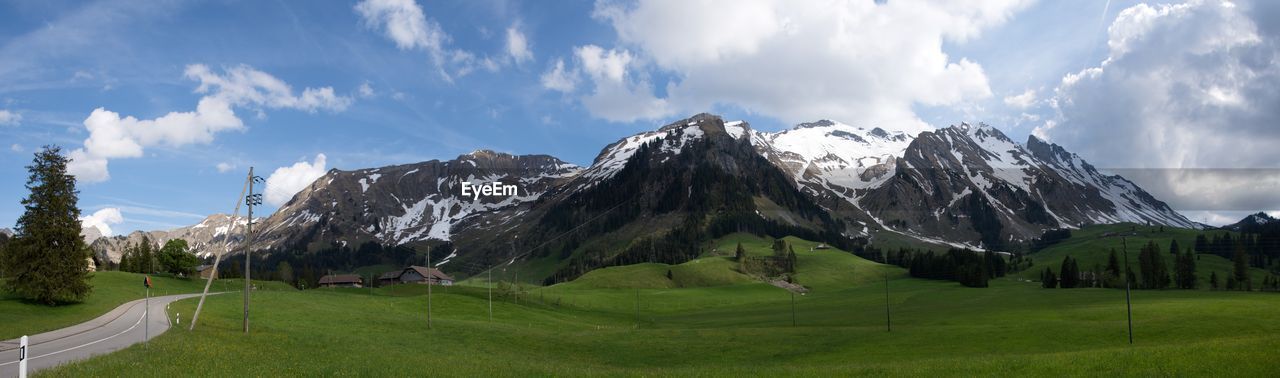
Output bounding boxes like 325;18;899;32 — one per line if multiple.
0;146;92;305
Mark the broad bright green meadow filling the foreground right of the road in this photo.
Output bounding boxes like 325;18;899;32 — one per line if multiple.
41;236;1280;377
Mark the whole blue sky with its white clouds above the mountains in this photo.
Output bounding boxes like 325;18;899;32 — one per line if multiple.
0;0;1280;233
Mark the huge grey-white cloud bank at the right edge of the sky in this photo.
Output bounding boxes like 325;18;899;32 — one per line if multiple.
1034;1;1280;219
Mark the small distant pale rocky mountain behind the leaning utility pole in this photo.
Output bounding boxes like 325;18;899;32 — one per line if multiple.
86;214;252;264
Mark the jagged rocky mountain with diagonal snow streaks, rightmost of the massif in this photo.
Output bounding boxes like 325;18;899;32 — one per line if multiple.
856;123;1197;249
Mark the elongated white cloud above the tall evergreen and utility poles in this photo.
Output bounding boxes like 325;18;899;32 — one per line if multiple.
67;64;351;182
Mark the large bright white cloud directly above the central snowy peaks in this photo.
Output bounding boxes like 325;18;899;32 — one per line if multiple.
550;0;1027;131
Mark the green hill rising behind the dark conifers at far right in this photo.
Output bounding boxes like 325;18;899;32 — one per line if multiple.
1011;224;1267;288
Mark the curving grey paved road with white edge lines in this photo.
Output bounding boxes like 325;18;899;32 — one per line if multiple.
0;293;214;377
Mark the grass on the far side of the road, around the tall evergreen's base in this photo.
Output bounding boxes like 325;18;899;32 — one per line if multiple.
0;272;288;340
